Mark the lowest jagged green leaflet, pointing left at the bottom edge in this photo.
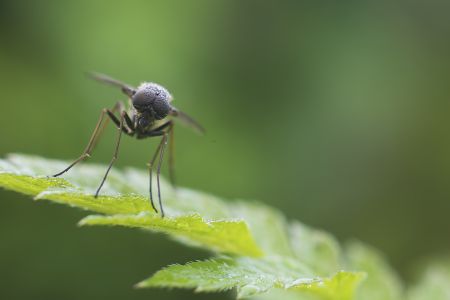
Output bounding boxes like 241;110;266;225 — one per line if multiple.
138;257;364;300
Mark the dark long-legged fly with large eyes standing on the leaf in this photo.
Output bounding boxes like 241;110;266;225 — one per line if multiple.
53;73;204;217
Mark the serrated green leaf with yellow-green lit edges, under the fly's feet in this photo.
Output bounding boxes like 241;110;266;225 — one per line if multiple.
0;154;364;300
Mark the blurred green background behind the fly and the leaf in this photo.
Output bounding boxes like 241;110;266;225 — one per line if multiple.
0;0;450;299
